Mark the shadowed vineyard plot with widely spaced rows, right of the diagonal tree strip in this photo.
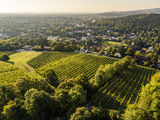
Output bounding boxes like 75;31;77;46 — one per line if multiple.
93;66;157;109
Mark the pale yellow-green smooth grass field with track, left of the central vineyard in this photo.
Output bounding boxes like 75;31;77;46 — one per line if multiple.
10;52;42;79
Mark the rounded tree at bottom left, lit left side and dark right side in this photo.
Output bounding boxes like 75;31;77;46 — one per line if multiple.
24;89;56;120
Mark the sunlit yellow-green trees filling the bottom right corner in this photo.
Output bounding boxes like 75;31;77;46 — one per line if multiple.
124;72;160;120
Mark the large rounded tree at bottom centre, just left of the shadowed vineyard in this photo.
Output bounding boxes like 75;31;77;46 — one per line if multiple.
55;76;87;111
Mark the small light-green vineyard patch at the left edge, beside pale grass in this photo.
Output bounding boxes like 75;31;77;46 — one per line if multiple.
0;61;24;86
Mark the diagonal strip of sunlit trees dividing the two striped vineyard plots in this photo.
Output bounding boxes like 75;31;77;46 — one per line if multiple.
90;56;132;87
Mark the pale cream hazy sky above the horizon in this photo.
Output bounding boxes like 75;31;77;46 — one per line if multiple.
0;0;160;13
